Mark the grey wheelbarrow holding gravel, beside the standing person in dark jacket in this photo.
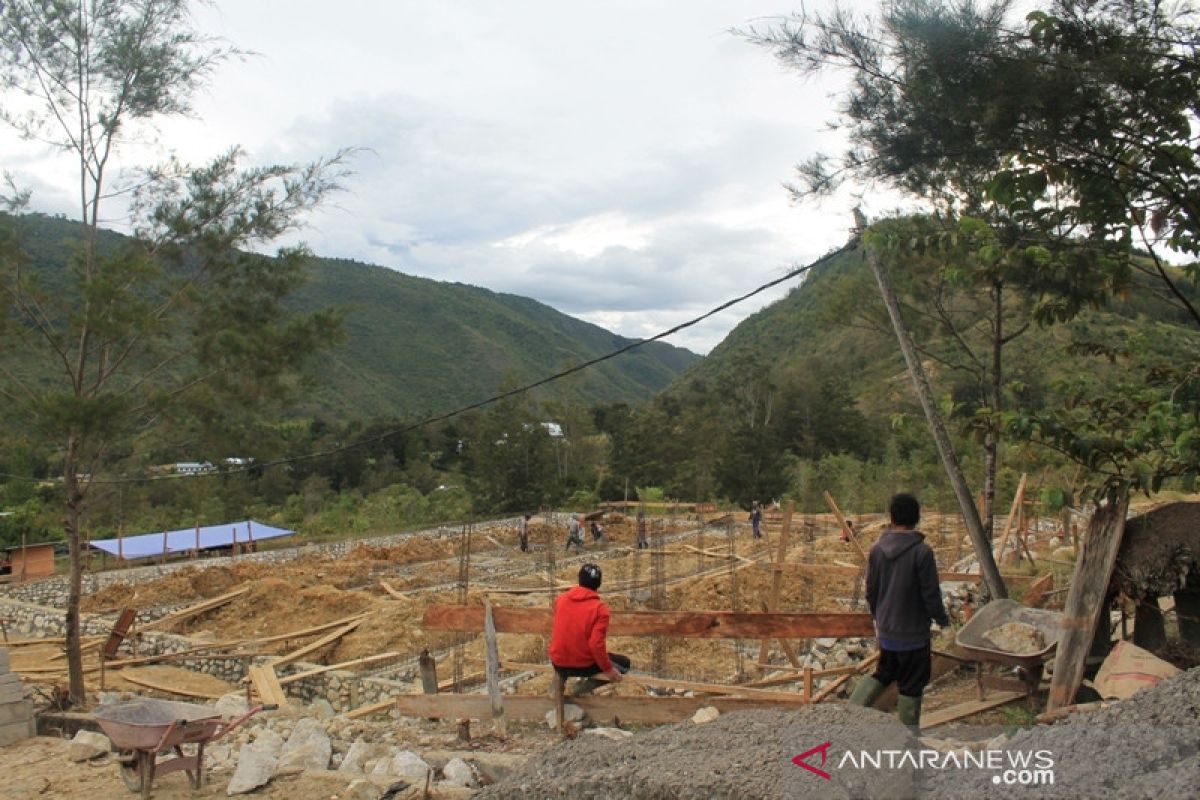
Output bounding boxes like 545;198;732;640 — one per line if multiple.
954;599;1062;699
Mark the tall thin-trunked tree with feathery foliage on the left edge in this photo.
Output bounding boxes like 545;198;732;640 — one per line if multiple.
0;0;343;700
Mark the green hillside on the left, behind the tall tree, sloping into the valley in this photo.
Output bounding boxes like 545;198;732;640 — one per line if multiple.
4;215;700;420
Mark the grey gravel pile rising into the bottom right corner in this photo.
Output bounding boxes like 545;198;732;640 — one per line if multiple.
922;668;1200;800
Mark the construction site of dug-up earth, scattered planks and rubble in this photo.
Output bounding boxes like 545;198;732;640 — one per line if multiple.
0;491;1200;799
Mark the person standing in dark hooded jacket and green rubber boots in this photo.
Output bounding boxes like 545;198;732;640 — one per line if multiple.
850;494;950;734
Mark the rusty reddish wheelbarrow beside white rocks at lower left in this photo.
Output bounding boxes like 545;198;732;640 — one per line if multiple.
92;698;276;798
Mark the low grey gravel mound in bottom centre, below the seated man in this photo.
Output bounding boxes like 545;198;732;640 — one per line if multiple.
478;705;914;800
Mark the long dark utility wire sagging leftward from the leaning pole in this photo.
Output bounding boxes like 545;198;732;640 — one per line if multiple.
0;236;858;485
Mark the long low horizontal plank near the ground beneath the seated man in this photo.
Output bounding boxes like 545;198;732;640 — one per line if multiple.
388;694;820;724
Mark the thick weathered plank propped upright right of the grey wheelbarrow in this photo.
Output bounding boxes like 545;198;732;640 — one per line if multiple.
1046;489;1129;711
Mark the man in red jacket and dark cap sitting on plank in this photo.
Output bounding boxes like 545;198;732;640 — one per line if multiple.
550;564;629;694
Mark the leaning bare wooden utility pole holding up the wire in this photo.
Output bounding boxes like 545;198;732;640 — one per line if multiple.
856;210;1008;600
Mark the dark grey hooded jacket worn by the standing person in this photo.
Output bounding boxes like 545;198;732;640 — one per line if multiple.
866;530;950;642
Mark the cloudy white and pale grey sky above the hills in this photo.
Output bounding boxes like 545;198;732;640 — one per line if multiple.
0;0;881;353
